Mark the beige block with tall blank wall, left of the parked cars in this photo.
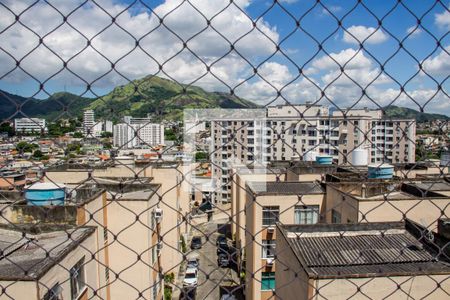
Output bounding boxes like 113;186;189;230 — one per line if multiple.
0;177;165;299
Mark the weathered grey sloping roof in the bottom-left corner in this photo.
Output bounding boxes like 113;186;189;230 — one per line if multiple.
0;225;95;280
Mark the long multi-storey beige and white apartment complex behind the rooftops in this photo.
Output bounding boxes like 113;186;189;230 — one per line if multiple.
211;104;416;202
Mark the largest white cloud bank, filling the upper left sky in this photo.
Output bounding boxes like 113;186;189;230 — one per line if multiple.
0;0;279;90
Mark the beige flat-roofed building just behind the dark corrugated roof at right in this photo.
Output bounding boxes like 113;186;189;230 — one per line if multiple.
326;180;450;230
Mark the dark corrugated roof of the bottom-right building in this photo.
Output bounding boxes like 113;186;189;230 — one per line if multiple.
277;221;450;278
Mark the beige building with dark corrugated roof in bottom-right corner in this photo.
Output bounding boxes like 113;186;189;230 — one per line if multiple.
276;220;450;300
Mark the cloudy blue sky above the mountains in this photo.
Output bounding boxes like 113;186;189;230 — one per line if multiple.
0;0;450;115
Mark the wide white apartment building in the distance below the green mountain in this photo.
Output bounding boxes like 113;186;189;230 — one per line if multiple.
113;116;164;149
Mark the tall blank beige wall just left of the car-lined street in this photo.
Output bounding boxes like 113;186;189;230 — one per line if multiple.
108;198;162;299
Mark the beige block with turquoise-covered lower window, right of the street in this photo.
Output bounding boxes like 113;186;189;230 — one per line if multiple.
241;181;325;300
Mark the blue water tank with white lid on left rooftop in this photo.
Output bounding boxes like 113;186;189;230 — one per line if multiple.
25;182;66;206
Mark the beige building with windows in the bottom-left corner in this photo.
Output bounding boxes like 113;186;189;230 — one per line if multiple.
0;224;100;300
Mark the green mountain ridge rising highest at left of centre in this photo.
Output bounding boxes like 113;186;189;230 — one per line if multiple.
0;76;257;121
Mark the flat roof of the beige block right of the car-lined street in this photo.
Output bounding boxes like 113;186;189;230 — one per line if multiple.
247;181;325;196
